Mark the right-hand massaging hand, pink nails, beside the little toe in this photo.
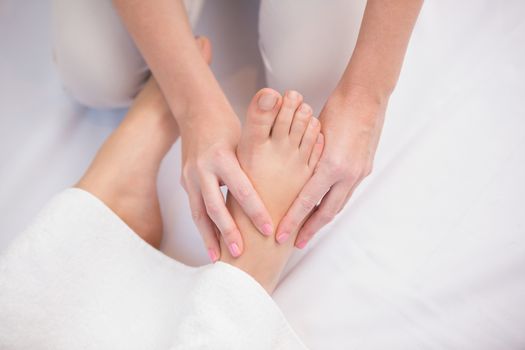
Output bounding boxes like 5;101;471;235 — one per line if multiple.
276;88;386;248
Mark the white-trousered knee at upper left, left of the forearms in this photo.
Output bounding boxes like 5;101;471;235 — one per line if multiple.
52;0;203;108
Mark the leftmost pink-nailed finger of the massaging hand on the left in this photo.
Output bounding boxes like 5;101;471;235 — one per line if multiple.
188;185;221;262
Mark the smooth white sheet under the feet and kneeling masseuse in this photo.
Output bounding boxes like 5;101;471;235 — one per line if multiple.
0;0;525;349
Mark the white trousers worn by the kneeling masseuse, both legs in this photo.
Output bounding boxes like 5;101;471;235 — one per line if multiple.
53;0;366;111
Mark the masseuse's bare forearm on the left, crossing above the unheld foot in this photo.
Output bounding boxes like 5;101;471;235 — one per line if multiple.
113;0;227;124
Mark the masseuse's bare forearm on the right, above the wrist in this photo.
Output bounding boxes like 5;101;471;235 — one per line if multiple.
338;0;423;103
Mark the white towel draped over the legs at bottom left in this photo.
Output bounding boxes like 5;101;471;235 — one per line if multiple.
0;189;304;350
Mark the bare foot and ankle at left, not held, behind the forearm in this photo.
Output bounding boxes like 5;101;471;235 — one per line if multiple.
76;38;211;248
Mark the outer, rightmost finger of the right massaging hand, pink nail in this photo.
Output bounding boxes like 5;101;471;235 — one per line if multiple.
295;182;348;249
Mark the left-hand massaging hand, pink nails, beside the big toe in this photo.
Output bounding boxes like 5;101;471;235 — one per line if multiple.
179;96;274;262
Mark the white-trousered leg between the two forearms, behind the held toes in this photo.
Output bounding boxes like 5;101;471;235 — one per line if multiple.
259;0;366;114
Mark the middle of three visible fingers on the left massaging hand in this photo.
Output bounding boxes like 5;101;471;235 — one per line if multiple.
200;177;243;258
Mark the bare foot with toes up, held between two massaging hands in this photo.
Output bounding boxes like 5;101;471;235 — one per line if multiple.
221;89;324;292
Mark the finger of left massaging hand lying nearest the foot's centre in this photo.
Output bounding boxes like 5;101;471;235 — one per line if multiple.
218;159;274;236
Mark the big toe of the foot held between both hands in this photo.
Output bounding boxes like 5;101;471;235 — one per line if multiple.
243;88;281;143
